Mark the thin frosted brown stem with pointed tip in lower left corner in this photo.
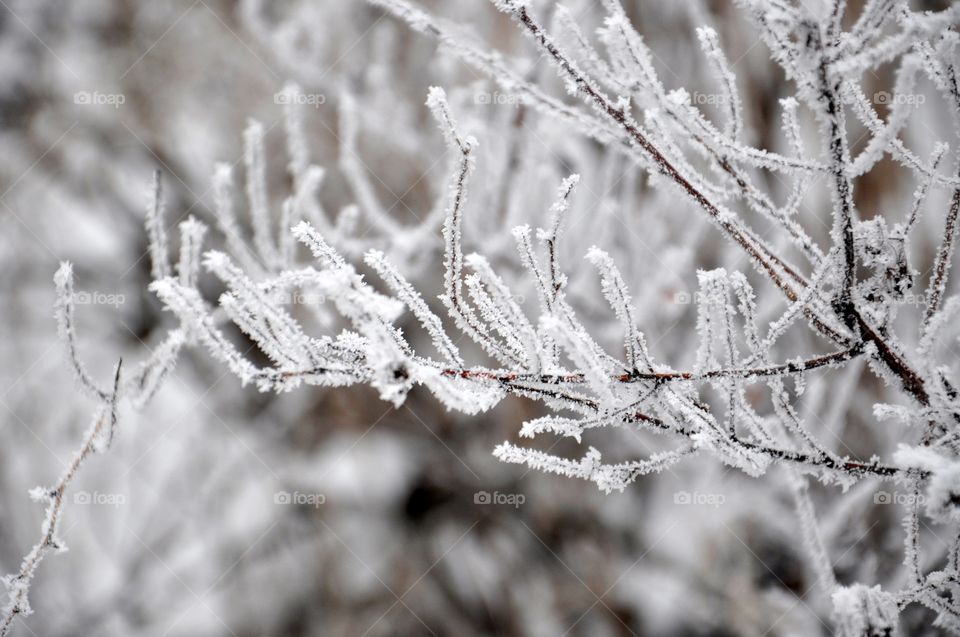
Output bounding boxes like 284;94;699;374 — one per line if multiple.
0;360;123;637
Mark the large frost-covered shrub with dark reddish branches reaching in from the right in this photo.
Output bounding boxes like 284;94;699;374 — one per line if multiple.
6;0;960;636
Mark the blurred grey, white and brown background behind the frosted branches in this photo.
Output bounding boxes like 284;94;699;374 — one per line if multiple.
0;0;953;637
